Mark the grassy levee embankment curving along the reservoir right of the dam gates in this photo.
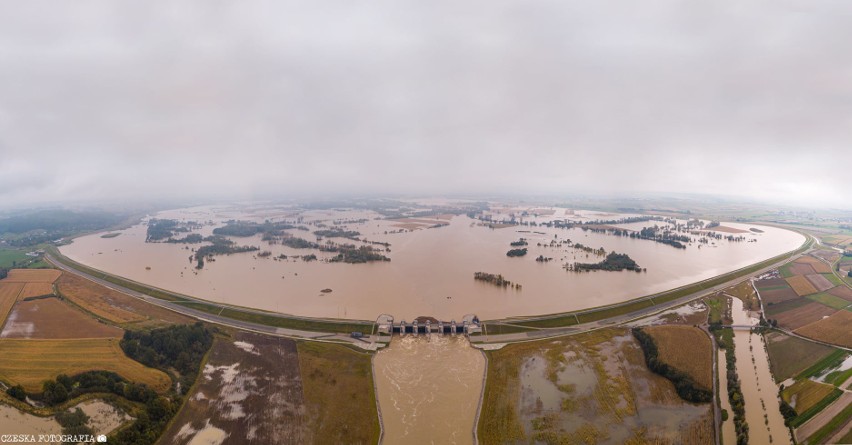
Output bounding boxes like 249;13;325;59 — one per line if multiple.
490;237;813;328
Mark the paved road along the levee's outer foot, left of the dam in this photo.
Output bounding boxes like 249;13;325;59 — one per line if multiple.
44;254;377;349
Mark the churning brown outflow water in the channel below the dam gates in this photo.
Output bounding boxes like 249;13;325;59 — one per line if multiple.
373;335;485;445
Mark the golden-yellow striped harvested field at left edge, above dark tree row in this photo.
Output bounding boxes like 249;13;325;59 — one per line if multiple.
0;338;171;392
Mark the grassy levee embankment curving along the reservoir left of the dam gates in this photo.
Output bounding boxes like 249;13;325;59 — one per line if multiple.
50;247;373;334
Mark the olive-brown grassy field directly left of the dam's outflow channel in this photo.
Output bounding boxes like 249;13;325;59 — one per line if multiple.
297;341;380;444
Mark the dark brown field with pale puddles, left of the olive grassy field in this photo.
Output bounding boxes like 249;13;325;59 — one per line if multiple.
160;332;313;445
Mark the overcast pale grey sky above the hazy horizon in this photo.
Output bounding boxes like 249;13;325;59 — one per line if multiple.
0;0;852;209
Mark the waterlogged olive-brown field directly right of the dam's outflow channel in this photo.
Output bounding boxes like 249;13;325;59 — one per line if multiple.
477;328;713;444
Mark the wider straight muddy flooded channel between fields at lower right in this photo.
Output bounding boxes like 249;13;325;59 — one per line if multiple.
731;298;791;444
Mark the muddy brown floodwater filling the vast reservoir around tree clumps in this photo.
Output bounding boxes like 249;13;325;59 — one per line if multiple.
61;207;804;320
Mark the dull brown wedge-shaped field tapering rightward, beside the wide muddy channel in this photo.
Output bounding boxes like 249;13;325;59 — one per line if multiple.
766;332;833;382
